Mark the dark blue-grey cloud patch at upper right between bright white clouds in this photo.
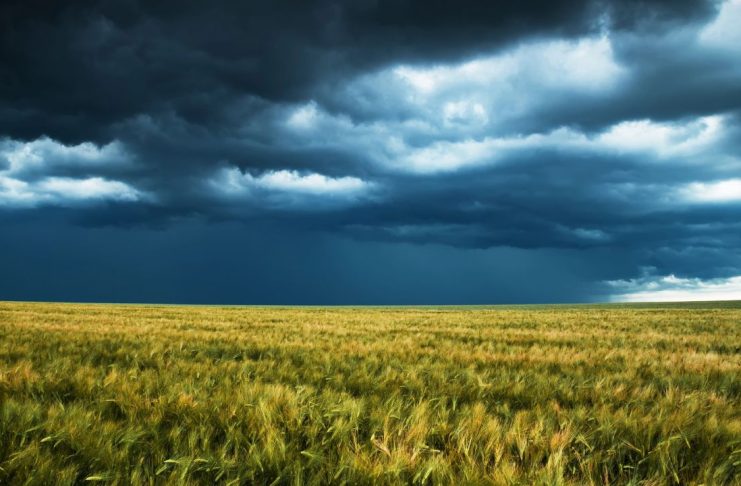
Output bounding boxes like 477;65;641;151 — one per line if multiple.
519;29;741;130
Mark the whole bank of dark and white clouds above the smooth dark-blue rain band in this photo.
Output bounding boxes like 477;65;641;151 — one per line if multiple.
0;0;741;300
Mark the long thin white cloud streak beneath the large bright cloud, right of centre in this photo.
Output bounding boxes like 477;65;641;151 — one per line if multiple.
276;111;732;174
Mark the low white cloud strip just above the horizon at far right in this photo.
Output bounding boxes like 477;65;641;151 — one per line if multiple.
607;275;741;302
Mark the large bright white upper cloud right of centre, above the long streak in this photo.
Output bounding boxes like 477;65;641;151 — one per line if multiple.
384;37;626;136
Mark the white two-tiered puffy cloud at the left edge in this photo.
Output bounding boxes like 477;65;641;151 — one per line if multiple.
0;137;144;207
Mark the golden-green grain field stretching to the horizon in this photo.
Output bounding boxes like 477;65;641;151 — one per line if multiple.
0;302;741;485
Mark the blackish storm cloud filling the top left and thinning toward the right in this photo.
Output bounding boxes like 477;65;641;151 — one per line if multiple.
0;0;715;142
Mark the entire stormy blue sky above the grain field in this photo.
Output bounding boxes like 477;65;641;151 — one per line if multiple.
0;0;741;305
